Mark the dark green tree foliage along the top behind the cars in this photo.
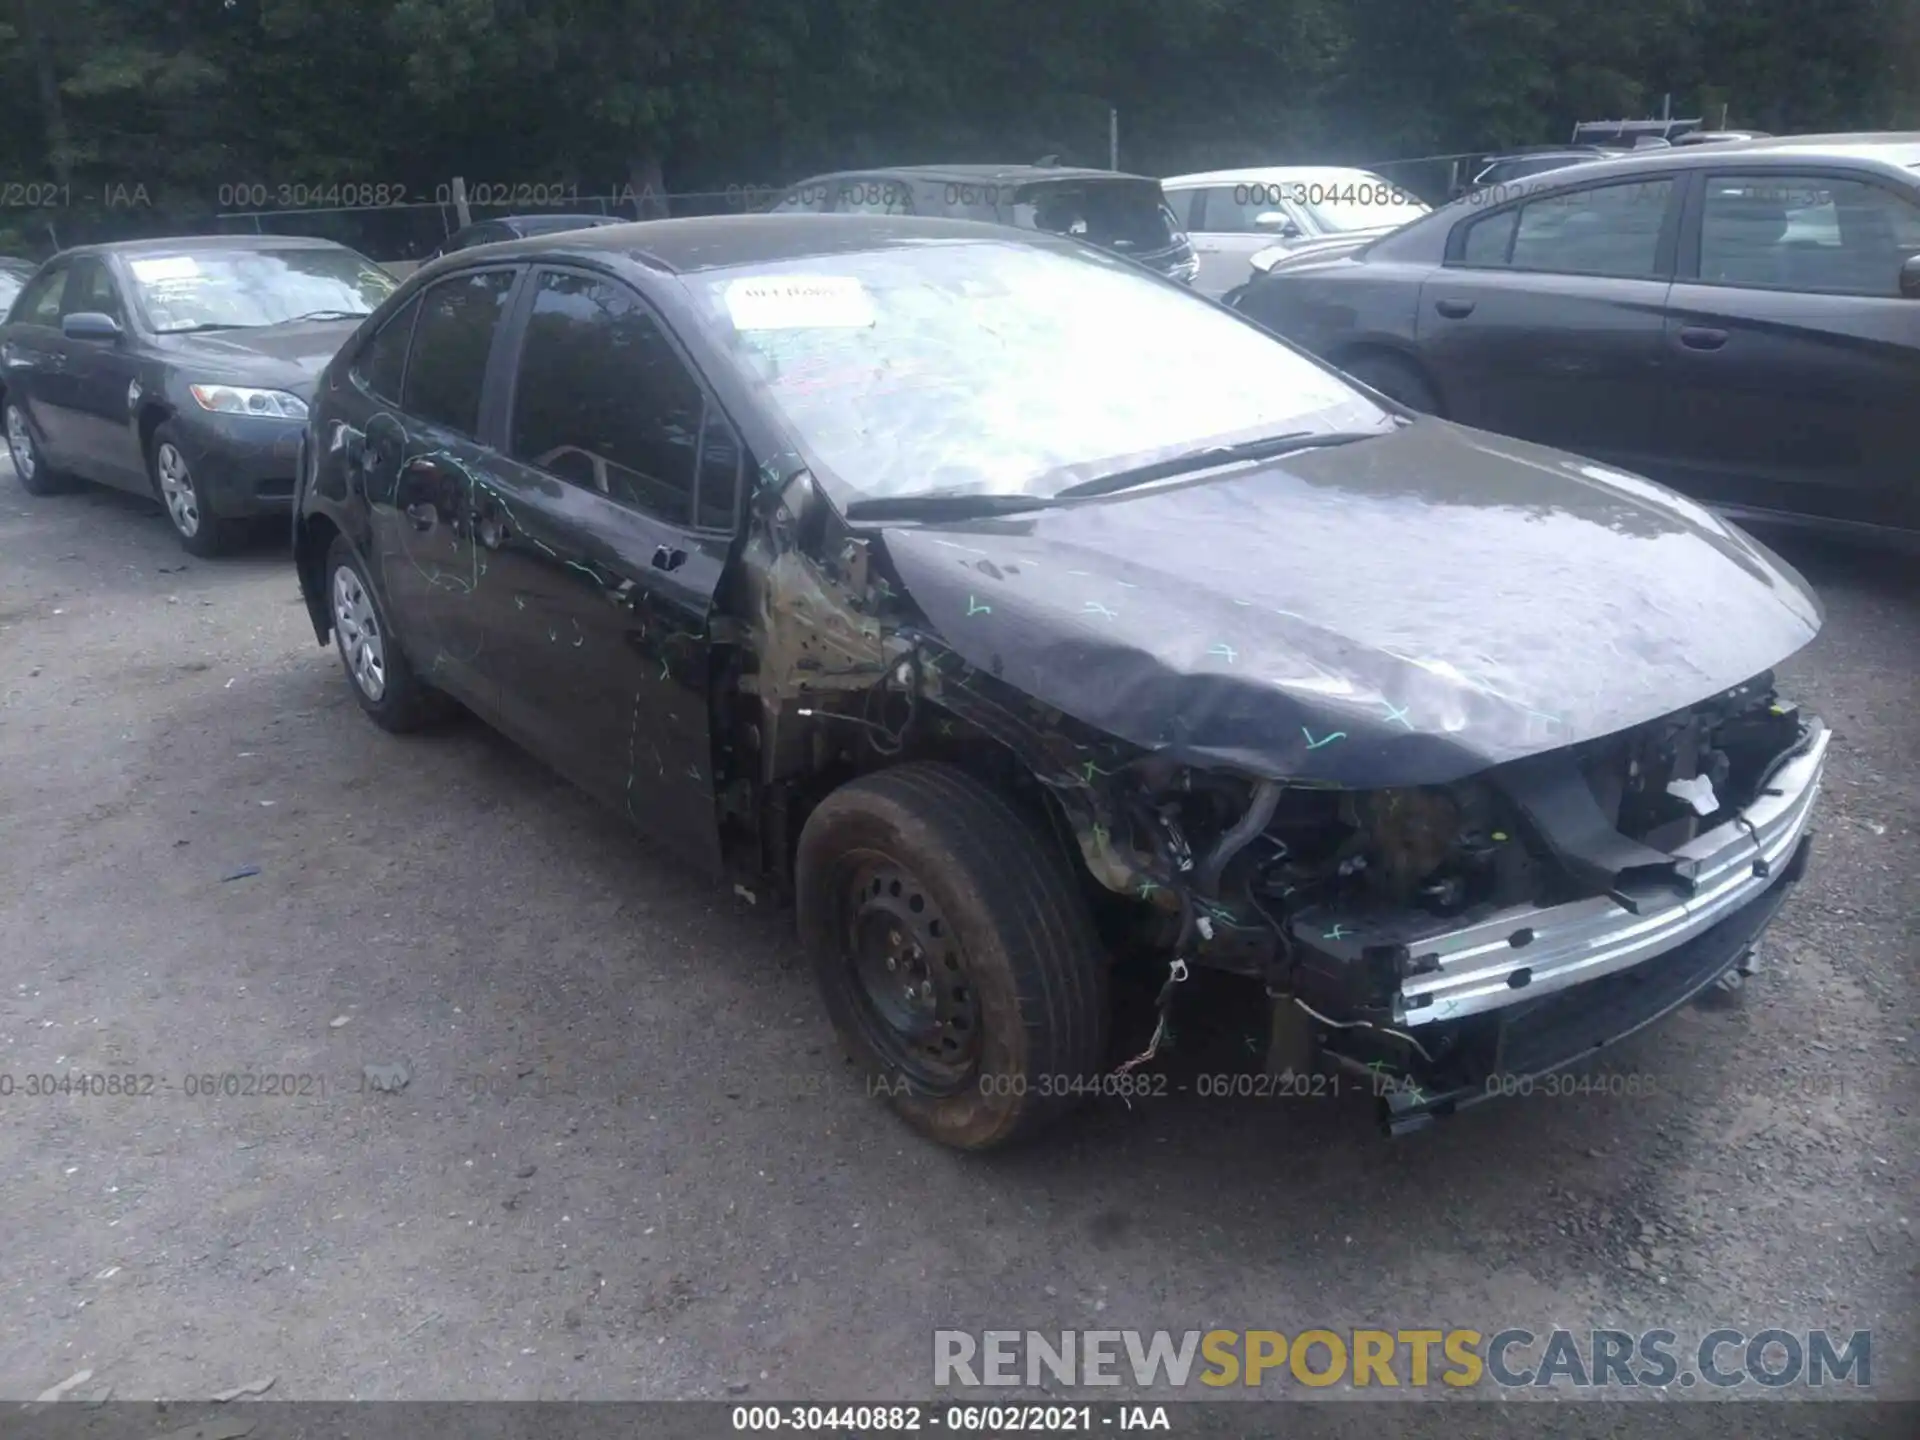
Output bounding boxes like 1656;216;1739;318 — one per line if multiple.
0;0;1920;250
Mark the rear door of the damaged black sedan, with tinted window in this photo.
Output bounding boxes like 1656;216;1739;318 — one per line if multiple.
363;265;520;710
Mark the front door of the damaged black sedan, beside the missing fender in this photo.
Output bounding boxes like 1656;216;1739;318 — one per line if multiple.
480;265;743;866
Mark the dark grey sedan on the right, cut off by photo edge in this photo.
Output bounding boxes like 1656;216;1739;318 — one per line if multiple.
1236;134;1920;538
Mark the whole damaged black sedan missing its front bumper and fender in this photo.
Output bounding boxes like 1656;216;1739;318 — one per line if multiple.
294;215;1828;1148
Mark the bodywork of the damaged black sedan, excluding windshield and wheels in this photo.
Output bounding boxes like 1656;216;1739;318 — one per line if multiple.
294;215;1828;1127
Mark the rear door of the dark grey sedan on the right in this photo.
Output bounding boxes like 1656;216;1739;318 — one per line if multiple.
1415;175;1680;465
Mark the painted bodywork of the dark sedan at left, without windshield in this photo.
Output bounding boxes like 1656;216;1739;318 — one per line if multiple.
0;236;391;518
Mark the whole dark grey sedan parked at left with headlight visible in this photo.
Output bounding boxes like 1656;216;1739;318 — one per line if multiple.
0;236;394;555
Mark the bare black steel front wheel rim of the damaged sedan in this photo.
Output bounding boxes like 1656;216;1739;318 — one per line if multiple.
845;852;983;1094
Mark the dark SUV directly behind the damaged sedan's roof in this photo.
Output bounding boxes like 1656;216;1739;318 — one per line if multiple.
768;165;1200;284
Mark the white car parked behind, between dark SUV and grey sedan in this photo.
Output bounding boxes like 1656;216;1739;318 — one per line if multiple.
1160;165;1430;296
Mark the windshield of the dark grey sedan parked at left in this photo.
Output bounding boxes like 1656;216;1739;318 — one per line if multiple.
127;248;396;334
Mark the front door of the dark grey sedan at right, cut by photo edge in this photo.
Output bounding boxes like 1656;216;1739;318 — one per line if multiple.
1663;165;1920;530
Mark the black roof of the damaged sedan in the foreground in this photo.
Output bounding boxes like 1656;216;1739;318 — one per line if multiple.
443;211;1110;275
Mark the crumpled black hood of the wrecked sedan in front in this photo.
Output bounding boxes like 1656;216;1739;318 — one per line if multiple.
885;419;1822;787
